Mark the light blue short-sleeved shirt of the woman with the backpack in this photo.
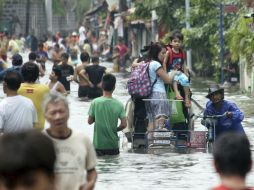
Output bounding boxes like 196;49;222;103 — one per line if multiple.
149;61;166;93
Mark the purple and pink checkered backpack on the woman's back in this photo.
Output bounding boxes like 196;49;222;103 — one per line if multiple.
127;62;157;98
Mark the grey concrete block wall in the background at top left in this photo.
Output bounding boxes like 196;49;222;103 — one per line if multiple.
0;0;77;38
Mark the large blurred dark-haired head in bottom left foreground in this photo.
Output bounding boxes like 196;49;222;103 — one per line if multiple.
0;130;56;190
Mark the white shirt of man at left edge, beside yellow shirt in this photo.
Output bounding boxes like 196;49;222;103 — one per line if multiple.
0;95;37;133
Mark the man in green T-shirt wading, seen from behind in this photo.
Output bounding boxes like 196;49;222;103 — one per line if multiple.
88;74;127;156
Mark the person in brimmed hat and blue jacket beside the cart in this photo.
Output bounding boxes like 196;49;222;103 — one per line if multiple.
204;85;244;137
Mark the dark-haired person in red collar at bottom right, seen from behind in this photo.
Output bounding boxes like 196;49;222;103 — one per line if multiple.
213;133;253;190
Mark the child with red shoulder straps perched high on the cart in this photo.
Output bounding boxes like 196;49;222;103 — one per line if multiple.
163;31;191;107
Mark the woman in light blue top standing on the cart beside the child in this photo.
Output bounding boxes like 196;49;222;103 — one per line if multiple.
133;43;180;131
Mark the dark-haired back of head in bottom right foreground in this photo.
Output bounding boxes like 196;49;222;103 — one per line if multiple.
213;132;252;178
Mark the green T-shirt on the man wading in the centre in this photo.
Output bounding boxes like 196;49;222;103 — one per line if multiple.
88;96;125;150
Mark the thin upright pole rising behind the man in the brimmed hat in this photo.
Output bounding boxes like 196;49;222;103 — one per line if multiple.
219;0;224;84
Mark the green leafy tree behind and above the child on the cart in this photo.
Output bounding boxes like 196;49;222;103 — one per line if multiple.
133;0;241;76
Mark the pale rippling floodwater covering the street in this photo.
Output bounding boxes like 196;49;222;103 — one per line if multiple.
0;59;254;190
